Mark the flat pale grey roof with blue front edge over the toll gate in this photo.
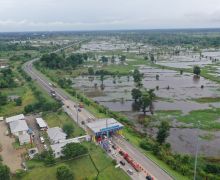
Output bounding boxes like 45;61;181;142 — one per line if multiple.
87;118;124;133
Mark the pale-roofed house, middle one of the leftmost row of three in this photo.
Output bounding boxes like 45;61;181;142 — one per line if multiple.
9;120;29;136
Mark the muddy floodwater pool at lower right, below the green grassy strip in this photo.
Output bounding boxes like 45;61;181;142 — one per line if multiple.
147;128;220;157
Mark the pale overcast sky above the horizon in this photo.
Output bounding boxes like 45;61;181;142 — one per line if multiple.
0;0;220;31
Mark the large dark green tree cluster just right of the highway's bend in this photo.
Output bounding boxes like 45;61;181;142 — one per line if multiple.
40;53;88;69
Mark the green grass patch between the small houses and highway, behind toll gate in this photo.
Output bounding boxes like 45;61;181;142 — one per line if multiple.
43;112;85;137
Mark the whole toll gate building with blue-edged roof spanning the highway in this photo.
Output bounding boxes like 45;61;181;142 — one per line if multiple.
87;118;124;141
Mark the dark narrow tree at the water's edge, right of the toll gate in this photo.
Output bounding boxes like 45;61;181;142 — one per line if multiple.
157;121;170;144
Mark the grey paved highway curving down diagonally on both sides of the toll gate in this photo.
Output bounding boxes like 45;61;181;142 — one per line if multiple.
22;46;173;180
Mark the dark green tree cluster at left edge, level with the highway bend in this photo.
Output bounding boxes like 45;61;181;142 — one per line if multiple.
0;68;16;88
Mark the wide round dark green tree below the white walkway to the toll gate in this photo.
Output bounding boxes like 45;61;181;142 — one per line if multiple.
62;143;88;159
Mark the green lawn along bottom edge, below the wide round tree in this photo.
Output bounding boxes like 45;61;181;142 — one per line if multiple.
21;143;130;180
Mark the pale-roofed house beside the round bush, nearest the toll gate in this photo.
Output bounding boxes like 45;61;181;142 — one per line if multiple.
47;127;67;144
